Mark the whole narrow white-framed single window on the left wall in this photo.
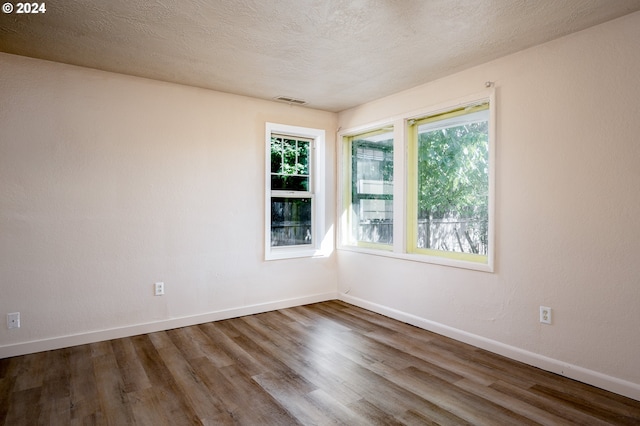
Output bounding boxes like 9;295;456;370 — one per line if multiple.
265;123;324;259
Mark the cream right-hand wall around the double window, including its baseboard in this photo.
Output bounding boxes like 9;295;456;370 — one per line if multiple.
338;13;640;399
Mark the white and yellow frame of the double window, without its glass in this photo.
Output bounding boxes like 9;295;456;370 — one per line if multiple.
337;88;496;272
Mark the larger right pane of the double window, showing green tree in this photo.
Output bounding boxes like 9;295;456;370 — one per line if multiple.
417;106;489;255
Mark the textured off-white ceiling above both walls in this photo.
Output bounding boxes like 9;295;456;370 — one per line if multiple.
0;0;640;111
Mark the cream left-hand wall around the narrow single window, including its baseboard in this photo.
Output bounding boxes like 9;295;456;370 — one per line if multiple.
0;54;337;357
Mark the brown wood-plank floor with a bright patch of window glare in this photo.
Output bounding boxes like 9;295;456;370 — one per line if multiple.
0;301;640;426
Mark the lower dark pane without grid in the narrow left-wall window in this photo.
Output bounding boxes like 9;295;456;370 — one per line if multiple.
271;197;312;246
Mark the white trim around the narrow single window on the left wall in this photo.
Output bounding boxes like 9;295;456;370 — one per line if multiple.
264;122;332;260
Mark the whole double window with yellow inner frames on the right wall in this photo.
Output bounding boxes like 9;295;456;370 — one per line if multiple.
339;90;495;271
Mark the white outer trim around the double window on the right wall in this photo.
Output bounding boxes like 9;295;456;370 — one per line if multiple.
337;89;496;272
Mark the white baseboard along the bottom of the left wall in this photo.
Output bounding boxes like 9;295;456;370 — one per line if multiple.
0;292;338;359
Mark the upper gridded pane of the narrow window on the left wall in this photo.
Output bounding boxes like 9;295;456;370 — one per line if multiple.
271;137;311;191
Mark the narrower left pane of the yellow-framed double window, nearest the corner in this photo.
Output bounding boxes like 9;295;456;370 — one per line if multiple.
350;131;393;244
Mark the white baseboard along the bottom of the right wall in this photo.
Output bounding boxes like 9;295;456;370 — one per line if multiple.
339;293;640;401
